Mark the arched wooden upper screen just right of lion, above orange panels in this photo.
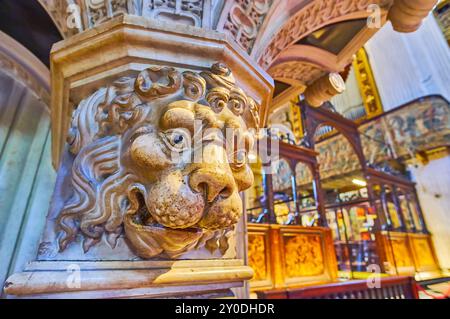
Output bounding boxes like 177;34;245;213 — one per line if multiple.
247;141;326;226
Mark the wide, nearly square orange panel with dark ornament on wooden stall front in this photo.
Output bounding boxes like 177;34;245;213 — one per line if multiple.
284;235;325;278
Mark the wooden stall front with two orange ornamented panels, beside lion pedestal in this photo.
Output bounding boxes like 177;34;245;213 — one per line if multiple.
248;224;337;291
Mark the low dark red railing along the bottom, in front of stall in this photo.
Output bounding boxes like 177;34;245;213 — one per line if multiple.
257;277;419;299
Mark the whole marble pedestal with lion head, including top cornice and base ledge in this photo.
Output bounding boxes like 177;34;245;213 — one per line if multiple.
6;15;273;297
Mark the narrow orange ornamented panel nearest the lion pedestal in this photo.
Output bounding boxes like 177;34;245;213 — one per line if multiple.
248;234;268;281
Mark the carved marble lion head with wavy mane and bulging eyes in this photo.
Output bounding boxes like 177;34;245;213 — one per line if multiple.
57;64;259;258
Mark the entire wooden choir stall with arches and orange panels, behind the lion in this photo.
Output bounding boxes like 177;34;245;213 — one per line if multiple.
246;105;440;292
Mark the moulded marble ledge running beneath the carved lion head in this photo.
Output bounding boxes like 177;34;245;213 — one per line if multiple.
4;259;253;299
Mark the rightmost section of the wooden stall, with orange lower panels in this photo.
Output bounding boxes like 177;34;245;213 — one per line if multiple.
368;168;439;276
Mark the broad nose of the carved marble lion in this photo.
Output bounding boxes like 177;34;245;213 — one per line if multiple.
189;169;235;202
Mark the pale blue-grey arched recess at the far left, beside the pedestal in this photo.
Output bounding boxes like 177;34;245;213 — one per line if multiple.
0;30;55;296
